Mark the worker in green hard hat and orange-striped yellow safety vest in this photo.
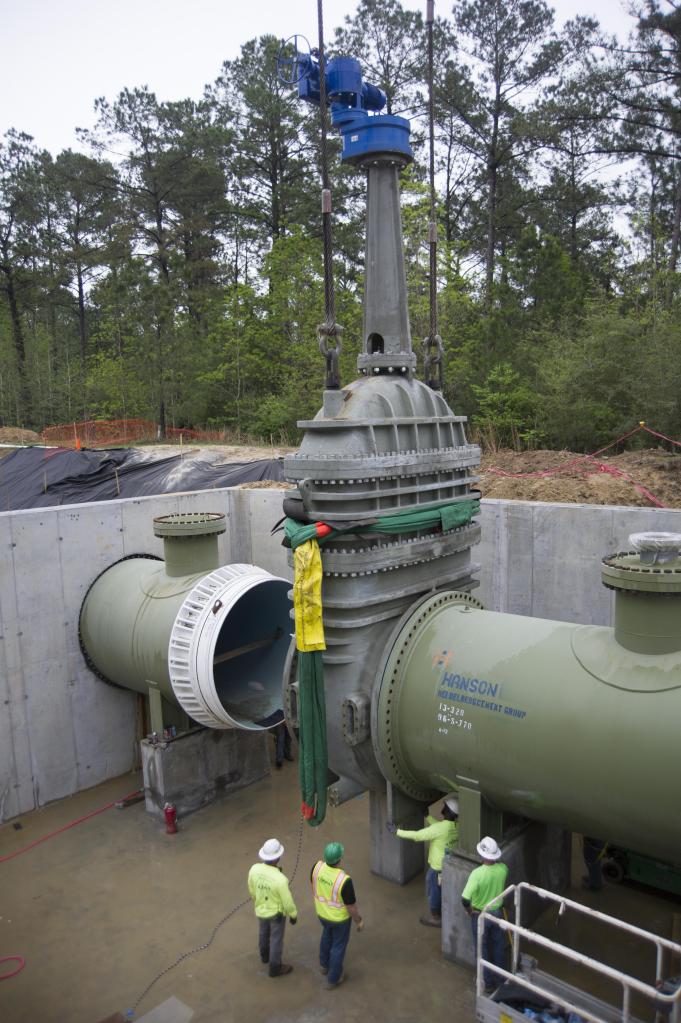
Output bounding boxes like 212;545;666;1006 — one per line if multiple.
310;842;364;988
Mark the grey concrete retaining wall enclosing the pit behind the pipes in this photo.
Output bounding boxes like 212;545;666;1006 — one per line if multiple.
0;489;681;820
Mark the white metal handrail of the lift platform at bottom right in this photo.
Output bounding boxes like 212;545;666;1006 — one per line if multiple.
476;881;681;1023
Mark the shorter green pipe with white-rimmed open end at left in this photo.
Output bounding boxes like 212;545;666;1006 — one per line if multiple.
80;514;290;729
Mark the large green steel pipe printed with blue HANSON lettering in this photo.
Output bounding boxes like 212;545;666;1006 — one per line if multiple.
373;591;681;862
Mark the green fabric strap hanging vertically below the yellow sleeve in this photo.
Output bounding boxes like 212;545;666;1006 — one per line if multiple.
298;650;327;828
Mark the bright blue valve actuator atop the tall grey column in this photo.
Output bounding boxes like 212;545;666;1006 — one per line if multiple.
298;54;413;163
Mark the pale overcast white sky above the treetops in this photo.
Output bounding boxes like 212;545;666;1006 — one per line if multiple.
0;0;633;154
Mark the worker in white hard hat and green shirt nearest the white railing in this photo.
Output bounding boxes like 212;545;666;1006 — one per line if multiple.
461;836;508;994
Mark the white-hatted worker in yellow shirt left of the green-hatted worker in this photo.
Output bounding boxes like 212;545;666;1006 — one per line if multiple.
248;838;298;977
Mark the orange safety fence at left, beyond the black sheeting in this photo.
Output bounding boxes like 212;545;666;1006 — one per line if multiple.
41;419;224;450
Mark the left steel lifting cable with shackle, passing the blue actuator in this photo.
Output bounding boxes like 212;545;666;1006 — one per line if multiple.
317;0;343;391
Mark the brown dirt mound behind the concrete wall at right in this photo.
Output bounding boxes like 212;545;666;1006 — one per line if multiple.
481;448;681;508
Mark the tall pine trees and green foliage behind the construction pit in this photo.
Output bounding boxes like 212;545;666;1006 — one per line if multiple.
0;6;681;450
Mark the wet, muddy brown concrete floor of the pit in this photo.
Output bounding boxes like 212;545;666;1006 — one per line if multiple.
0;752;678;1023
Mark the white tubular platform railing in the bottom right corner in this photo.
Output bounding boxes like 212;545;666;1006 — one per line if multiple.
476;881;681;1023
